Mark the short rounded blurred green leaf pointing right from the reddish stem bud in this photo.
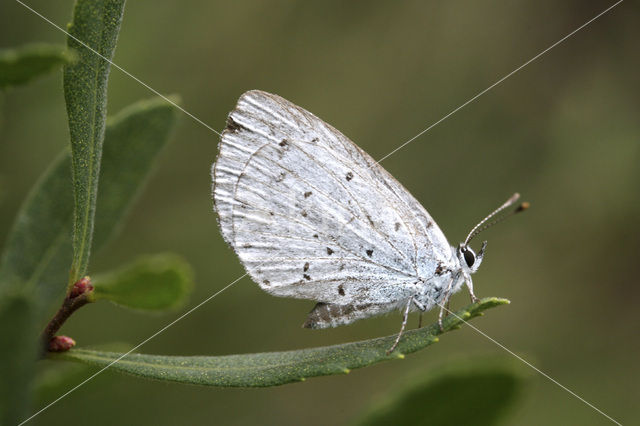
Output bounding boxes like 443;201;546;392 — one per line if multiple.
91;254;193;311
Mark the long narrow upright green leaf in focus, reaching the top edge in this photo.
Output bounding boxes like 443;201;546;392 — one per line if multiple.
64;0;124;285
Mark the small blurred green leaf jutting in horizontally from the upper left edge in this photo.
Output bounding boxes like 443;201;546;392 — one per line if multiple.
0;44;76;89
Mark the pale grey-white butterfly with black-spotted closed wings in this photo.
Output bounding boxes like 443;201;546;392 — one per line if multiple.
211;90;527;352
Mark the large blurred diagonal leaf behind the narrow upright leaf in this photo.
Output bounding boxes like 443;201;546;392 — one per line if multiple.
0;98;177;306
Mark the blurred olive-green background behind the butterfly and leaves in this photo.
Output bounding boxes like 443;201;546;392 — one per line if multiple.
0;0;640;425
